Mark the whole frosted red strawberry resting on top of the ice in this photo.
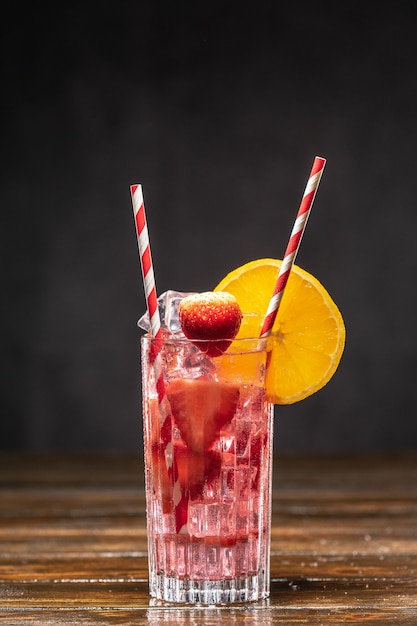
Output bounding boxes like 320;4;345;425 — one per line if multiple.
178;291;242;357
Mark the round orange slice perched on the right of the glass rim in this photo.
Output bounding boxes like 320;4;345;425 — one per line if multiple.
215;259;346;404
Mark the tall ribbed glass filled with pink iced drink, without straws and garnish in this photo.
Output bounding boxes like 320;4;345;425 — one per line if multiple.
142;334;273;603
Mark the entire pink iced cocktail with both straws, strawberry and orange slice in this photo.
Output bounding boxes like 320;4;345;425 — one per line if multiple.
131;157;345;604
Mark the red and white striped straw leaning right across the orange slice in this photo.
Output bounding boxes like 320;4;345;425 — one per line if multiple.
260;156;326;337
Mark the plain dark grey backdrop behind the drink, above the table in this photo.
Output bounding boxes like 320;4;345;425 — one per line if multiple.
0;0;417;452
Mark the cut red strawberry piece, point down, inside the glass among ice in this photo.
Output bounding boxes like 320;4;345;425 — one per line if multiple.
166;378;239;454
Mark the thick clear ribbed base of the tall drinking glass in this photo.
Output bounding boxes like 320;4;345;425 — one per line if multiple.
150;574;269;604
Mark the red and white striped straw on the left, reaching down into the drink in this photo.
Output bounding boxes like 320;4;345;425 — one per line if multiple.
130;185;188;532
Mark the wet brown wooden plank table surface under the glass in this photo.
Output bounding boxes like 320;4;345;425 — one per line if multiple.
0;453;417;626
